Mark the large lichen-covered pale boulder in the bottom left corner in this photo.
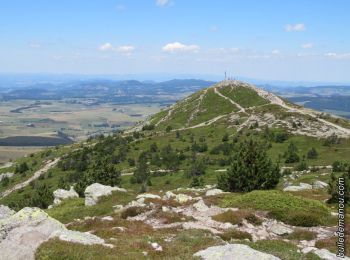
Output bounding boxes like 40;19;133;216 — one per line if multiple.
0;207;109;260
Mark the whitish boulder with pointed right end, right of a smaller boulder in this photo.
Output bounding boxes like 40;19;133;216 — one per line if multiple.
84;183;126;206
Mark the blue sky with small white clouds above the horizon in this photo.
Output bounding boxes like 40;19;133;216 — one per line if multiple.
0;0;350;82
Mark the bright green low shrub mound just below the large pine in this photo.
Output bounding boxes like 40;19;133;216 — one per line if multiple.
222;190;332;226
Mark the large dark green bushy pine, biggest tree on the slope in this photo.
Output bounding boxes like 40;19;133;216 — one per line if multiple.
218;139;280;192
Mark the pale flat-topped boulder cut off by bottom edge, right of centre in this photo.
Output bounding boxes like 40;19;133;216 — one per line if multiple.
193;244;280;260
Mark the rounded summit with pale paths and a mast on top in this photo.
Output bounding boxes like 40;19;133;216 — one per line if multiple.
146;80;350;137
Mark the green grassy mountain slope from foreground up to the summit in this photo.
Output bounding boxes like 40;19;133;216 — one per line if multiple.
0;81;350;259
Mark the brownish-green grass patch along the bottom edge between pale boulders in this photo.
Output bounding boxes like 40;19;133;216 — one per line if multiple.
36;229;220;260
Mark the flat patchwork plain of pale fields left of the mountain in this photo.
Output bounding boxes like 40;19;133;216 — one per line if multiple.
0;100;160;163
